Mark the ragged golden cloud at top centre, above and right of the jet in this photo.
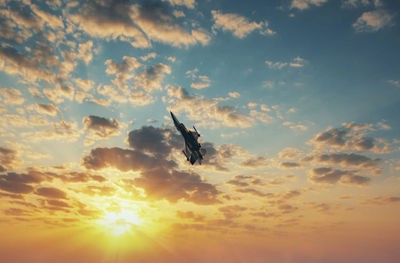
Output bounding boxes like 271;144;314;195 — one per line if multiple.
211;10;275;38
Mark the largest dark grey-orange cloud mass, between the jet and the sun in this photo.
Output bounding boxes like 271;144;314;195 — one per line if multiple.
82;127;220;204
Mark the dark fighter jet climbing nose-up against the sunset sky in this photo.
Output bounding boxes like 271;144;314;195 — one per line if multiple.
170;111;206;165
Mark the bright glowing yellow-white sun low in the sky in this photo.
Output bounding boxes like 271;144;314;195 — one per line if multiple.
97;209;142;236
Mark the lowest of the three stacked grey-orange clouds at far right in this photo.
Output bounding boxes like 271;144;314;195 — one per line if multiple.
308;167;371;187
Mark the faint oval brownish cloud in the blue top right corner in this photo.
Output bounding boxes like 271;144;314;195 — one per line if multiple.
353;10;393;32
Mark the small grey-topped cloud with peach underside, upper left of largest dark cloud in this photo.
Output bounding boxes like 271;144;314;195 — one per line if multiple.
82;115;120;139
